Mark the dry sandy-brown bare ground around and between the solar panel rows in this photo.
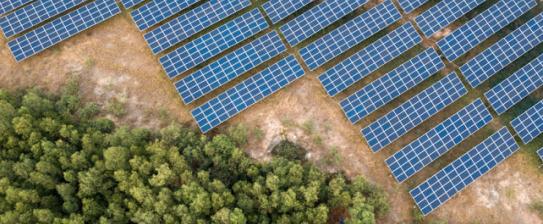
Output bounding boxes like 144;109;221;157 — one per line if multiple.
0;0;543;223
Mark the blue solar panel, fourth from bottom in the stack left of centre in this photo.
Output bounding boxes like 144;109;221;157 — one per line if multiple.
144;0;251;54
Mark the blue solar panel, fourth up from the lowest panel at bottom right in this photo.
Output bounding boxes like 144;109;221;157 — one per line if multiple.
340;48;445;124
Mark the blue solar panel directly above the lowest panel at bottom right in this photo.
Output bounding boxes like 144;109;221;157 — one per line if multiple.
386;99;492;182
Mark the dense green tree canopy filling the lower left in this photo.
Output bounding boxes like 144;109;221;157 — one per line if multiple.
0;85;387;223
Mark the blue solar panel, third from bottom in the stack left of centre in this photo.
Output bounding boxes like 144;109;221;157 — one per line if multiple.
160;9;269;78
